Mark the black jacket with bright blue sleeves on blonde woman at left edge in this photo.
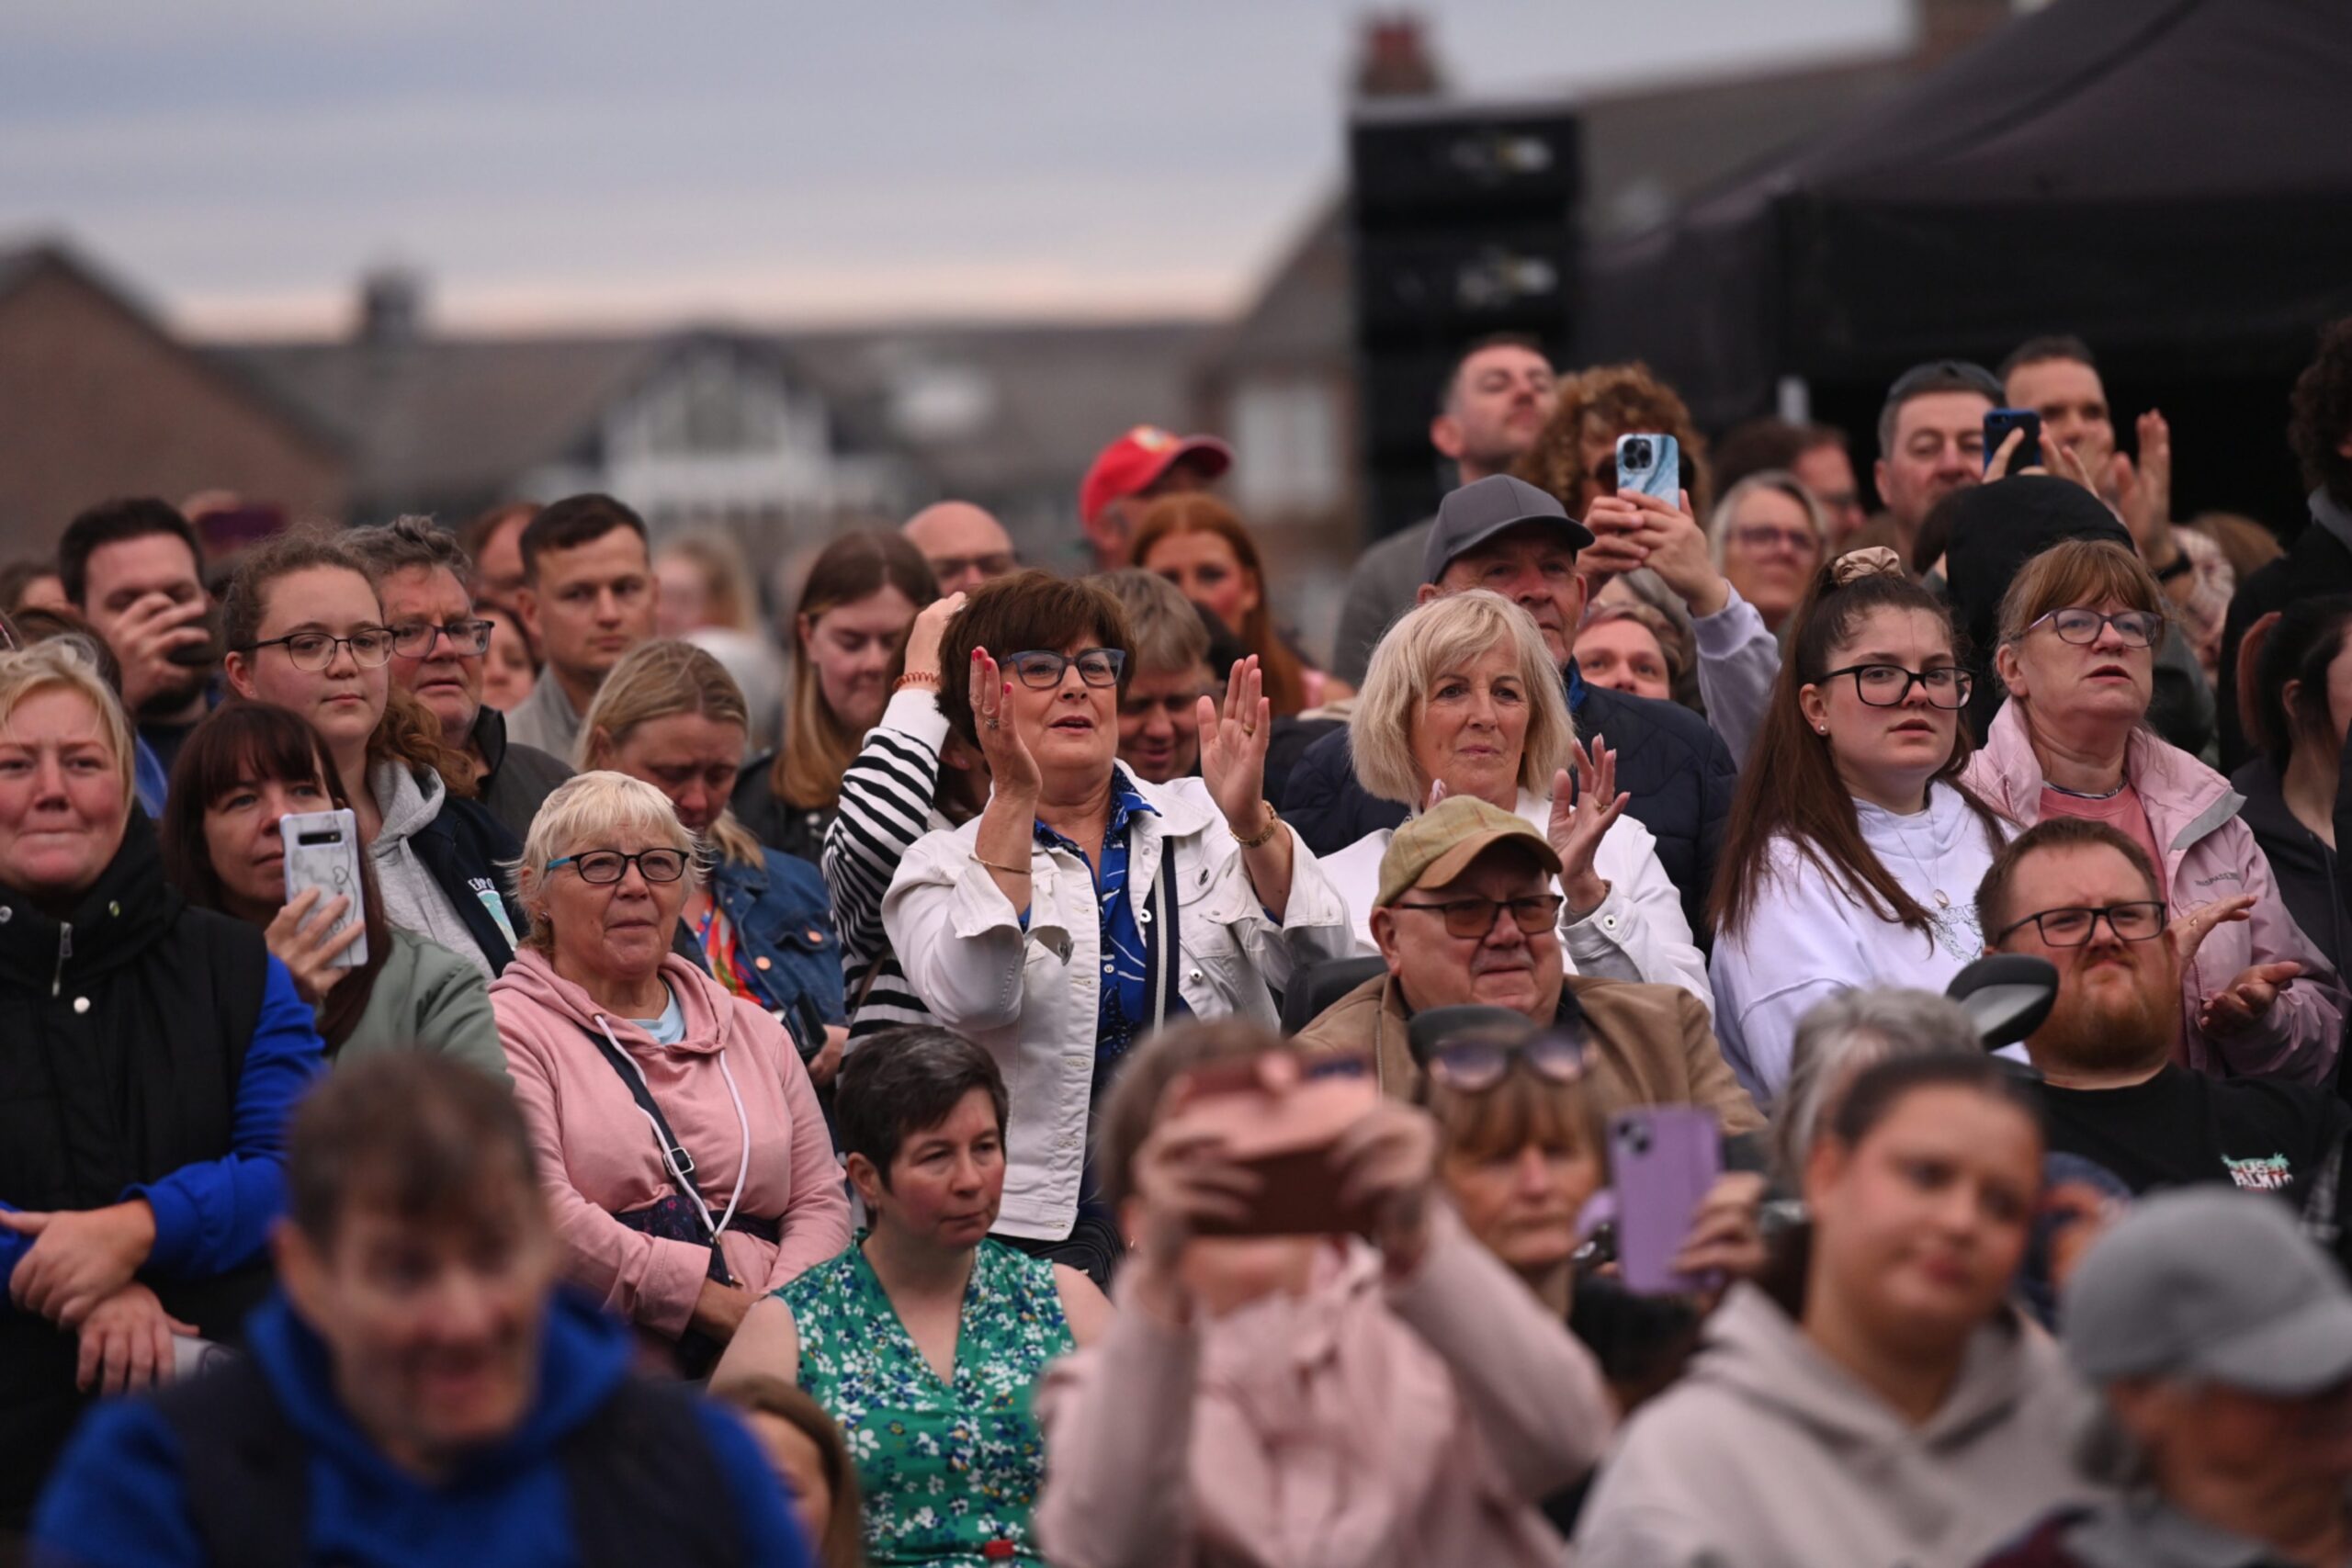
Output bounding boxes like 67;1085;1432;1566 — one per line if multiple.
0;808;322;1533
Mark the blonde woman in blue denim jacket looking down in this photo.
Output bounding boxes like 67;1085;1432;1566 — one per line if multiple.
574;639;847;1084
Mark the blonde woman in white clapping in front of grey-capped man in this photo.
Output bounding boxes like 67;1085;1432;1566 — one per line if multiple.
1322;588;1714;1010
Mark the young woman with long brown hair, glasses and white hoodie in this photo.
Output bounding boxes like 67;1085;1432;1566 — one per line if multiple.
1710;550;2007;1105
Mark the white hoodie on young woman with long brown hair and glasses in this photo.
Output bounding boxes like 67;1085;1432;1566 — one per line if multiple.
1708;785;1999;1107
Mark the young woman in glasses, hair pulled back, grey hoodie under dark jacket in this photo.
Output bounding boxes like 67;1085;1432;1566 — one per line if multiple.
221;531;520;978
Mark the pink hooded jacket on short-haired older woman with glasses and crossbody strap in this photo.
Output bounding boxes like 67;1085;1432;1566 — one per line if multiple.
489;947;849;1337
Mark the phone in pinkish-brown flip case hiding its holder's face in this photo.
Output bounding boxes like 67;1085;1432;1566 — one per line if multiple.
1173;1055;1381;1236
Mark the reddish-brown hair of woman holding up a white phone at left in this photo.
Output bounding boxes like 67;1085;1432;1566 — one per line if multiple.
155;698;393;1055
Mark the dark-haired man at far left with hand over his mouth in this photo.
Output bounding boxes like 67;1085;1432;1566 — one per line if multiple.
56;499;221;773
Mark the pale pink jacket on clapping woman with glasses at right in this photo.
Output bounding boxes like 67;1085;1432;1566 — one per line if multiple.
1966;703;2345;1084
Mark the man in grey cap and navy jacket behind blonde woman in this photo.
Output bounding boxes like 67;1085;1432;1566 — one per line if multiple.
1282;475;1736;933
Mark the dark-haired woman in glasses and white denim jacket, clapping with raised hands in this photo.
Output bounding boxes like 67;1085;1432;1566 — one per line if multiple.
882;571;1350;1279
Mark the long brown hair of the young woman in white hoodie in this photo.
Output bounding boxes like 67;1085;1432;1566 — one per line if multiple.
1710;559;2002;936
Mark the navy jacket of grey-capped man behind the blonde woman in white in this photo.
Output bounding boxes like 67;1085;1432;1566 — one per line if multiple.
1282;660;1738;931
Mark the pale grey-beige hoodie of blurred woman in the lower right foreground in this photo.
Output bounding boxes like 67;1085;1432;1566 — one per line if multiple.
1574;1286;2103;1568
